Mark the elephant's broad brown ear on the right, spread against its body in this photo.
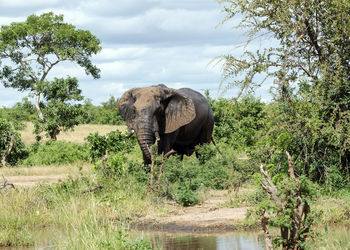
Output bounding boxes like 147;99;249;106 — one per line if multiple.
164;90;196;134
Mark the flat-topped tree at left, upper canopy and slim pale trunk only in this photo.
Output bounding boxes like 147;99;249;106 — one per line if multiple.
0;12;101;139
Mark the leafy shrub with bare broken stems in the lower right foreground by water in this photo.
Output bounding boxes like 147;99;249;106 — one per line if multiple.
255;164;319;249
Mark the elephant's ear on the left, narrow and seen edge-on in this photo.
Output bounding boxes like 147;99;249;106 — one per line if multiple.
118;88;137;128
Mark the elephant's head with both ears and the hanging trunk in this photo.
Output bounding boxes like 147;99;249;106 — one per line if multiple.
118;85;196;164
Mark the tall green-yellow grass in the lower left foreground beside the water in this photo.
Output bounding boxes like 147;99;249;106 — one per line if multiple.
0;170;174;249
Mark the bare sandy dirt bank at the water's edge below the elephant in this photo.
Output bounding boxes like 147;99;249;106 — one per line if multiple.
132;191;252;232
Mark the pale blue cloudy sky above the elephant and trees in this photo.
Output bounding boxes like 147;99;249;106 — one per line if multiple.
0;0;267;107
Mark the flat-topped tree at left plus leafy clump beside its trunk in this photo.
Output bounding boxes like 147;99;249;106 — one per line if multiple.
0;12;101;139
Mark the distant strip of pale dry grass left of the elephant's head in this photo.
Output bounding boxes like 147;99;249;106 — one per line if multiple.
21;122;127;145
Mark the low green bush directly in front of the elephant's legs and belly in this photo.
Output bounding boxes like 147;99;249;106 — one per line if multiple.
155;145;253;206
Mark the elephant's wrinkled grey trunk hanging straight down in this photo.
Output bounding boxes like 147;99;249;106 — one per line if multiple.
136;124;154;164
